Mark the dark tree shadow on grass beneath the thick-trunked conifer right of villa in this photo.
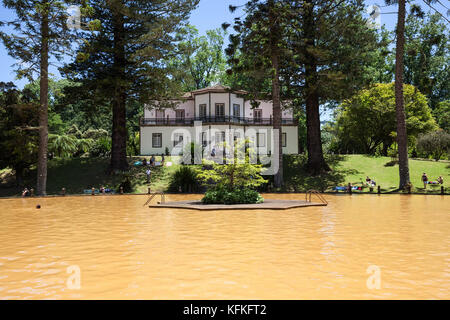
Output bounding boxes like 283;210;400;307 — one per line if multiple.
283;154;360;192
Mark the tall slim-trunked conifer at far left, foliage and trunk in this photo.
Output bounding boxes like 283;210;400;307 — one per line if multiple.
0;0;89;195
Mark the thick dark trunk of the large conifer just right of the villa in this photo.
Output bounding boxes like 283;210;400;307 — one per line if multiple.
304;0;330;175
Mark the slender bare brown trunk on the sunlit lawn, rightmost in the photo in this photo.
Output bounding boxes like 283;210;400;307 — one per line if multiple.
395;0;410;189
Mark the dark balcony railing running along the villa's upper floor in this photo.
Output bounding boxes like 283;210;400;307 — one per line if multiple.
141;116;295;126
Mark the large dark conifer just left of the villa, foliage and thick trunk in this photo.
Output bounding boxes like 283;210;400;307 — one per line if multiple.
64;0;198;172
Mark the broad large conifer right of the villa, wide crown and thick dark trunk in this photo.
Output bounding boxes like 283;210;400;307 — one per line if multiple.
227;0;378;175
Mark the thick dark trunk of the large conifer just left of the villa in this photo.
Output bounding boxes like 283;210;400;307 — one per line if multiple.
110;7;128;172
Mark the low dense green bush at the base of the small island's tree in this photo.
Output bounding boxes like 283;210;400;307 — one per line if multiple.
202;188;264;204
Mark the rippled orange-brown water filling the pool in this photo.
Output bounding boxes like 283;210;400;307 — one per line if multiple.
0;195;450;299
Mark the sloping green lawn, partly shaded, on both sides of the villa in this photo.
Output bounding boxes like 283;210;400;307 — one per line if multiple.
0;155;450;197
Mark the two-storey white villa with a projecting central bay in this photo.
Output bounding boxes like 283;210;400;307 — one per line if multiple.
140;85;298;155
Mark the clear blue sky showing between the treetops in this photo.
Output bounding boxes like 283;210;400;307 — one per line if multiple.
0;0;450;87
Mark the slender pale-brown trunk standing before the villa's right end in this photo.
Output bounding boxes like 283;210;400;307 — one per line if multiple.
269;1;283;188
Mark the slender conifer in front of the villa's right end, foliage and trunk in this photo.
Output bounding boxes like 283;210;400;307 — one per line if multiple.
223;0;288;188
